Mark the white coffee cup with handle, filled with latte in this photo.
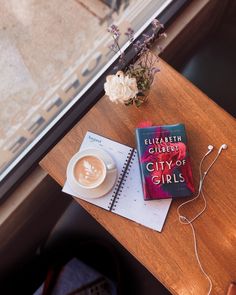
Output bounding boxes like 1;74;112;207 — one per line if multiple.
67;149;115;190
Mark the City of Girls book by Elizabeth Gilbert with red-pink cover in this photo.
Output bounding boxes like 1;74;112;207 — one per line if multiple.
136;124;194;200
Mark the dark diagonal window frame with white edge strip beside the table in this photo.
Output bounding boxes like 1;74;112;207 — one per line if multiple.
0;0;190;202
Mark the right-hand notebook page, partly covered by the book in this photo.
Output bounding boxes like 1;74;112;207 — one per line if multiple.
112;150;171;232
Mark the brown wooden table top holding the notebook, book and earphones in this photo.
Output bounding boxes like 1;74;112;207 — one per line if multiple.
40;61;236;295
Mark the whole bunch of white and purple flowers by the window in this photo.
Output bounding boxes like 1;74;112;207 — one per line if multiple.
104;19;166;107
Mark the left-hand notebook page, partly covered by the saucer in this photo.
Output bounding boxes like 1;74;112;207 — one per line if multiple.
62;131;131;210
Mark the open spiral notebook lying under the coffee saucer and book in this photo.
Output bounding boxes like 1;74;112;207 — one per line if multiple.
63;132;171;232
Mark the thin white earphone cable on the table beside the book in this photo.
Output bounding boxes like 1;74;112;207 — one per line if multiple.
177;151;224;295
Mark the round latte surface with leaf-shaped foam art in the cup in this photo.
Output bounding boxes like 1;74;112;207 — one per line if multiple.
74;155;105;188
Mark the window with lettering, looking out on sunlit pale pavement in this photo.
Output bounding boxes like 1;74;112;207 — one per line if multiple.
0;0;188;200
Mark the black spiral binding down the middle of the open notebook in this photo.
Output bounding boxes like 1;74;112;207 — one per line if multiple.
108;149;137;211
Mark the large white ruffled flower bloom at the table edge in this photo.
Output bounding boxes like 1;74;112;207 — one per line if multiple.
104;71;138;103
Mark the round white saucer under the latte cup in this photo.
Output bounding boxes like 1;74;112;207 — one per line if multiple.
66;148;117;199
